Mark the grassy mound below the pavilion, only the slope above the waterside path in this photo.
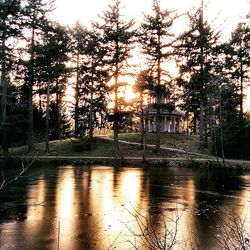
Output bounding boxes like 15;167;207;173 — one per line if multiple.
7;133;199;157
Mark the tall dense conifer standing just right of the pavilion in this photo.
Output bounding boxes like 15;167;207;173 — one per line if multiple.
176;3;218;148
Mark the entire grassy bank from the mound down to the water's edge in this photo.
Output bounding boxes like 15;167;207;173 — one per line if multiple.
4;134;250;169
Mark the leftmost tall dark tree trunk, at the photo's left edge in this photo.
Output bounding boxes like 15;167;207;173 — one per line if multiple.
1;26;8;155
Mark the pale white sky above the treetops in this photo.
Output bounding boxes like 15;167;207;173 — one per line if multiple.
53;0;250;39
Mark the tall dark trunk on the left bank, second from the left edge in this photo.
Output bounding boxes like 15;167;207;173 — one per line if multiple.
27;25;35;151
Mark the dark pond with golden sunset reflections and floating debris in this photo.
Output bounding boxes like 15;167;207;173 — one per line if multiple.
0;165;250;250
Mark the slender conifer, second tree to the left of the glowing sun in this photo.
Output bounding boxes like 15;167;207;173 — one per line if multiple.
78;30;109;141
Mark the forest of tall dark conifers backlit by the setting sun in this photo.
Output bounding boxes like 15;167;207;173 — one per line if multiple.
0;0;250;159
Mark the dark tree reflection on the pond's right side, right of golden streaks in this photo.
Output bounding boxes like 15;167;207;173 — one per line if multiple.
192;169;245;248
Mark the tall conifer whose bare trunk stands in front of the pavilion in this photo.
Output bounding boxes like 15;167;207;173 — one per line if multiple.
139;0;177;153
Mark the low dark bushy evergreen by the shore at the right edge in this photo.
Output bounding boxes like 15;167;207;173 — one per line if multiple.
212;83;250;158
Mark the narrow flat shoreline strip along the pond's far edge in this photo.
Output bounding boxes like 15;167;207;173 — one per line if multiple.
0;155;250;171
